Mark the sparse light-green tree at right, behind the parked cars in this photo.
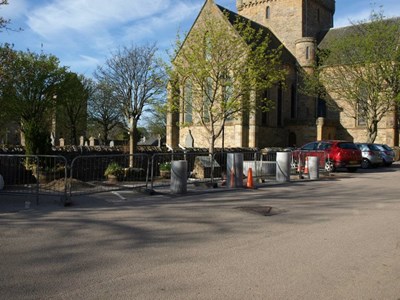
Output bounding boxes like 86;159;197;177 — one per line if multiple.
306;12;400;144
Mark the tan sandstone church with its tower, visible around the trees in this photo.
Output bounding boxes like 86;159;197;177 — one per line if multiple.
166;0;398;149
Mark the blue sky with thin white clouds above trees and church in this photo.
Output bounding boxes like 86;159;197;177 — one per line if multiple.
0;0;400;77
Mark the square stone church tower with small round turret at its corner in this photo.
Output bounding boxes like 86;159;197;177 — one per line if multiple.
236;0;335;67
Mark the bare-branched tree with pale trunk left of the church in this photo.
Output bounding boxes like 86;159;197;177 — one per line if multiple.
95;44;166;167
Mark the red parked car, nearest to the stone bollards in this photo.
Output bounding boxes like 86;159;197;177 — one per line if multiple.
292;140;362;172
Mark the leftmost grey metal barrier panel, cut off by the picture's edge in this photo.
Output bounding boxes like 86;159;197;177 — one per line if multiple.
0;154;67;203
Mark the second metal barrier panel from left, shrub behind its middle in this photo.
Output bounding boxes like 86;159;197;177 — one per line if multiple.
69;154;149;196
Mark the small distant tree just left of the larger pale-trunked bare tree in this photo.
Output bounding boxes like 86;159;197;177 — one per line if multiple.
88;82;123;143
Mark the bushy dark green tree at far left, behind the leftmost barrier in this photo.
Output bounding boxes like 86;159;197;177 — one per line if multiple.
1;51;65;154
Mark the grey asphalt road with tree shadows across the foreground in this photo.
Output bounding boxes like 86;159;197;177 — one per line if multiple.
0;163;400;300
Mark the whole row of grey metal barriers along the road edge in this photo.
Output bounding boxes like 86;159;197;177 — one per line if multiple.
0;151;290;203
